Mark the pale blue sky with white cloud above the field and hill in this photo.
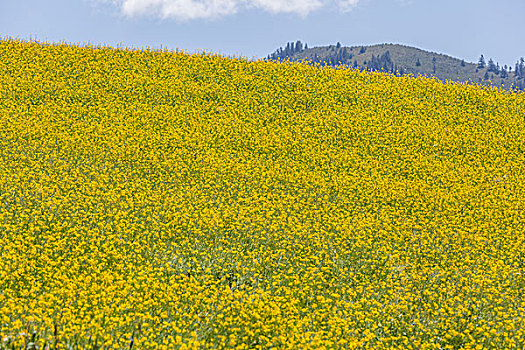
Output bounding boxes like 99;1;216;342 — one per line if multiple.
0;0;525;66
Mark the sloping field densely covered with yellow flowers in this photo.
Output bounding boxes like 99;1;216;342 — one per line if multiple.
0;38;525;349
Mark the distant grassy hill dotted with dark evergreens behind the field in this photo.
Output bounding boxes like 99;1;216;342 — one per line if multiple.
267;41;525;90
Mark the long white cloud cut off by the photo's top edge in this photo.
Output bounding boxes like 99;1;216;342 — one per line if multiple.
105;0;360;21
